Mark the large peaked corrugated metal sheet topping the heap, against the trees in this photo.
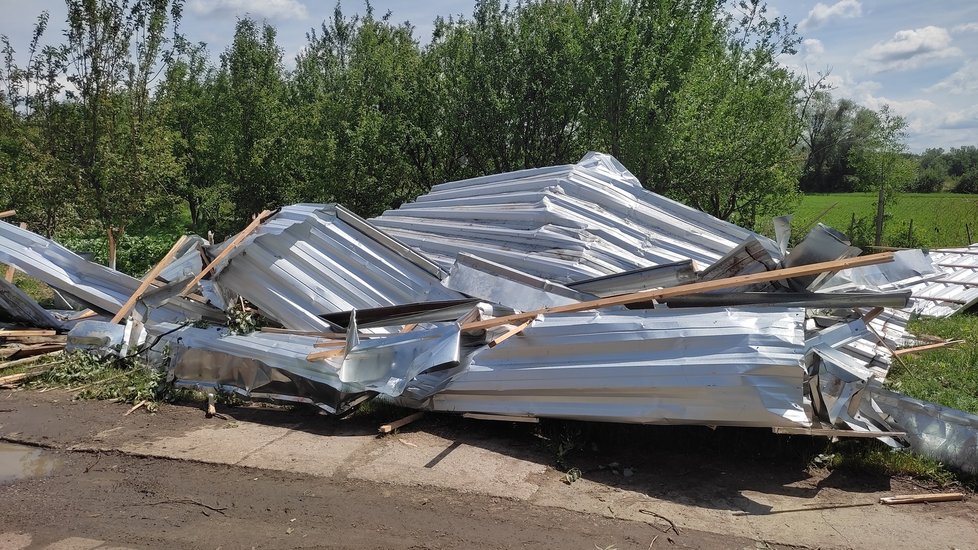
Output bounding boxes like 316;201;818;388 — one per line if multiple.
373;153;780;283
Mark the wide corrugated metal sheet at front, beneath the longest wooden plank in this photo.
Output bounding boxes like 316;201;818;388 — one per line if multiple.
406;308;810;427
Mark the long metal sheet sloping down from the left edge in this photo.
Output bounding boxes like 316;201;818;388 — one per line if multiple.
0;221;225;322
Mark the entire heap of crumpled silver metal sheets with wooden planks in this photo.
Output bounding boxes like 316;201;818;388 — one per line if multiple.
0;153;978;474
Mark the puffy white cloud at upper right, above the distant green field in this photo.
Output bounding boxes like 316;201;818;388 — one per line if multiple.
864;25;961;72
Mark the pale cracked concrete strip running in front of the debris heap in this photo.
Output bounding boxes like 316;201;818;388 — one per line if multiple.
0;392;978;549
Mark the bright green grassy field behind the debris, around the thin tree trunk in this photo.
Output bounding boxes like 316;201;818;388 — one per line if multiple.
780;193;978;247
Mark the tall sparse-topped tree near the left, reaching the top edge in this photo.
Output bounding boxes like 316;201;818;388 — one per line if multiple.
65;0;182;268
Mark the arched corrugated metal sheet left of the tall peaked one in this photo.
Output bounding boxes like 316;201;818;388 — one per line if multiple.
202;204;465;331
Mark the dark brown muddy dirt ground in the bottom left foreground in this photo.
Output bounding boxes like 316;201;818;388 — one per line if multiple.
0;451;755;550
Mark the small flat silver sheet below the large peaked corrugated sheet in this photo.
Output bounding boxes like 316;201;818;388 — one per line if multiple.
443;253;594;311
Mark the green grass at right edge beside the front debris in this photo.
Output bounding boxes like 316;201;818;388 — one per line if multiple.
887;313;978;414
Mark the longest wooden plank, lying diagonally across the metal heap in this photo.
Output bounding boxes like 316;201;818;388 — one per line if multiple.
462;252;893;332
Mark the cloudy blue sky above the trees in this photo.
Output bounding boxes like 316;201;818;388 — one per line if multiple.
0;0;978;152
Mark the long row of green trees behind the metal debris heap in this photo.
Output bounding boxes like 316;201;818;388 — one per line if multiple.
0;0;973;270
